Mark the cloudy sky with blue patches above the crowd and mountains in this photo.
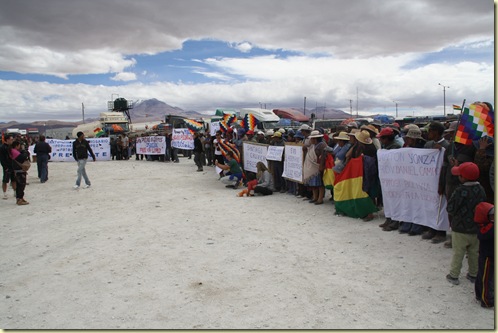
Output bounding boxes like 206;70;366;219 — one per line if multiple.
0;0;494;121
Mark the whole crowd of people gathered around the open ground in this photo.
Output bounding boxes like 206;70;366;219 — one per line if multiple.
0;113;494;307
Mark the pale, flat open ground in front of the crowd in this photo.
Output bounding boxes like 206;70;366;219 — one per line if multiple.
0;158;495;329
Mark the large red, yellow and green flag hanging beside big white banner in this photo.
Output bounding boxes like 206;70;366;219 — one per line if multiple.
334;156;377;218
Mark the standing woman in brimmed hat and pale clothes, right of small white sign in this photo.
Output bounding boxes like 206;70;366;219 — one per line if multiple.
303;130;327;205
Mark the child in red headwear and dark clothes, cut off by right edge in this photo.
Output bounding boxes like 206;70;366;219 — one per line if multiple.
474;202;495;308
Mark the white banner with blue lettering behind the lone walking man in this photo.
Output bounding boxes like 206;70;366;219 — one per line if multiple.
45;138;111;162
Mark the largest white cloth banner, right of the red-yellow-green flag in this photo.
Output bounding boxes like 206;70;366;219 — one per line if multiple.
377;148;449;230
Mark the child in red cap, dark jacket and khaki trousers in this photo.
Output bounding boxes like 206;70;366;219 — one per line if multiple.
446;162;486;285
